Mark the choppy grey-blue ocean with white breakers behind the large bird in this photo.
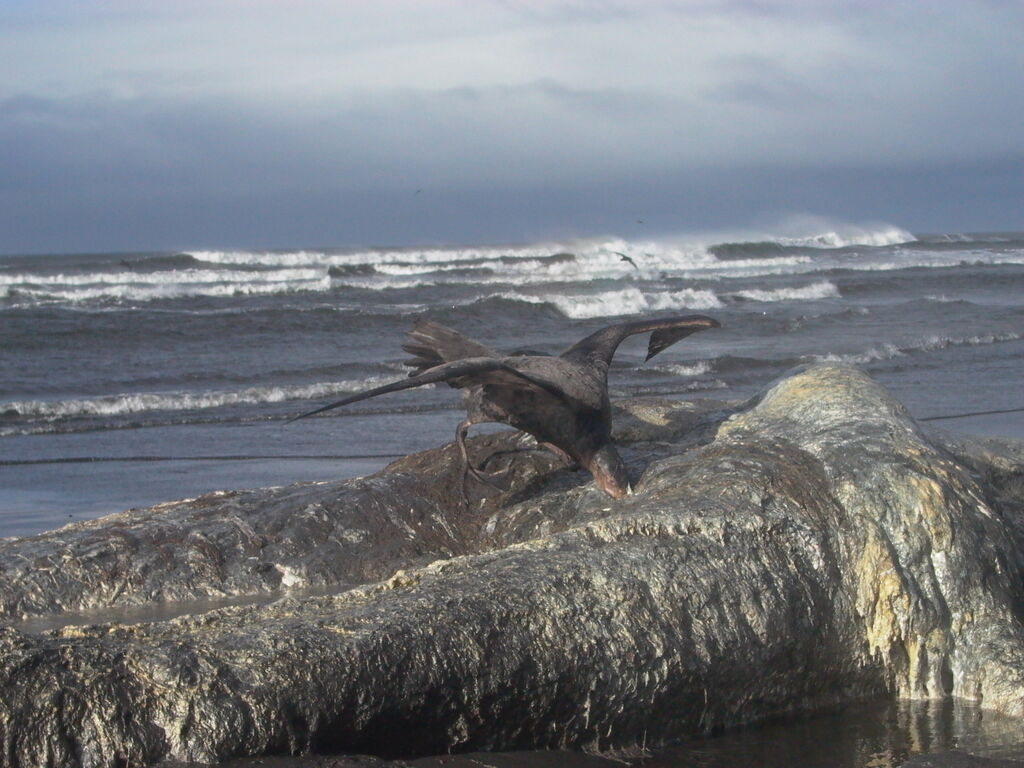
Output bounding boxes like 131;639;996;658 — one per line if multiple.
0;227;1024;537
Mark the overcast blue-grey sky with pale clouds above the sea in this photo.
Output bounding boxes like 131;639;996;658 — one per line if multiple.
0;0;1024;253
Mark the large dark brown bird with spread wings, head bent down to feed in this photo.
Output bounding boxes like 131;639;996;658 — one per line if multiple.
292;314;719;499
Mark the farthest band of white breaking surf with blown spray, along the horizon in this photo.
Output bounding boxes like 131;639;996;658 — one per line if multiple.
172;228;1024;290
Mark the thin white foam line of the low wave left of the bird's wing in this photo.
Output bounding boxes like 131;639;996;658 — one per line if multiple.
0;376;402;420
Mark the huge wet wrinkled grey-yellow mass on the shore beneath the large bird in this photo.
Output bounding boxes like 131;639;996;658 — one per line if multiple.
0;366;1024;766
